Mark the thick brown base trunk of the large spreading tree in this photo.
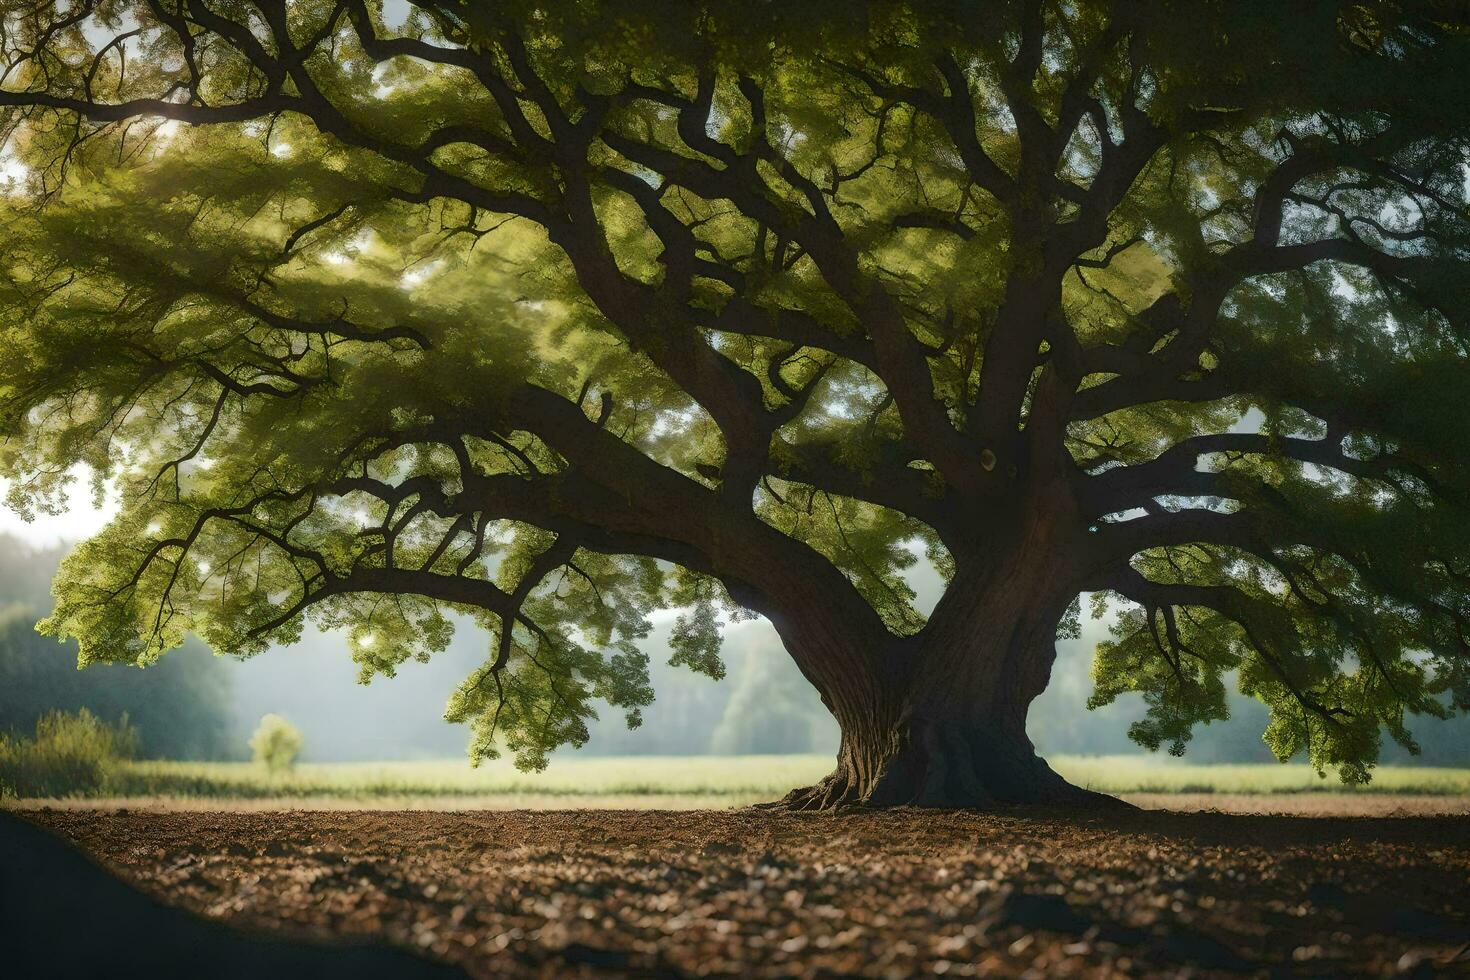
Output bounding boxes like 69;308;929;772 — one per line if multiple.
772;490;1126;810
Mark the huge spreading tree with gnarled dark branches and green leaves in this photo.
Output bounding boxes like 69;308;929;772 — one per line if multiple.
0;0;1470;807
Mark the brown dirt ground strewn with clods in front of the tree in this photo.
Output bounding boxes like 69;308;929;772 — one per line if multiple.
14;810;1470;977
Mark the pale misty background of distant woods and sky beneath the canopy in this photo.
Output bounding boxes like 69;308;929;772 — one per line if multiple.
0;486;1470;765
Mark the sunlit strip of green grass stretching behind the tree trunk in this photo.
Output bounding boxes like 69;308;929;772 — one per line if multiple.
88;755;1470;807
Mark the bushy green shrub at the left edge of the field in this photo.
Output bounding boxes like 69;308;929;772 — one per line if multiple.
0;708;138;796
